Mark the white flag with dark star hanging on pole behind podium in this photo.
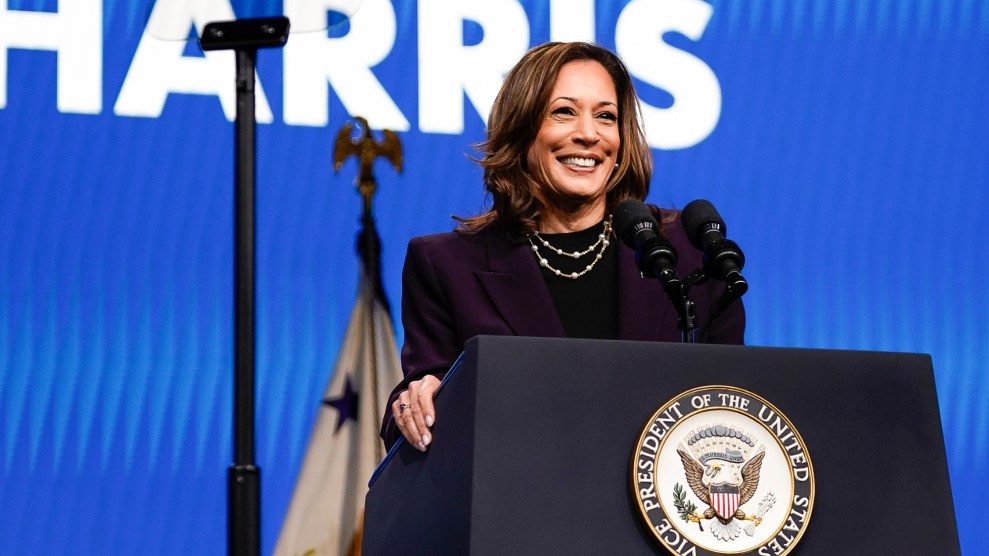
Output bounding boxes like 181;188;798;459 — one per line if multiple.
275;216;402;556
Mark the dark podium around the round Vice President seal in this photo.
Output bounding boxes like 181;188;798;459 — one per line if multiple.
364;336;960;556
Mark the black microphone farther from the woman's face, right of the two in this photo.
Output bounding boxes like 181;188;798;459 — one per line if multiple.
680;199;749;299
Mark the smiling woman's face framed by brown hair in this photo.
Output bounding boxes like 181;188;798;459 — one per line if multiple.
527;60;621;213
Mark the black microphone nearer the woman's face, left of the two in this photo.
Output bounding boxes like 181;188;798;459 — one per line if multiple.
614;199;683;296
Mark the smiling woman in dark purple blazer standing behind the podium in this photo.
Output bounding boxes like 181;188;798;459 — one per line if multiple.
381;43;745;451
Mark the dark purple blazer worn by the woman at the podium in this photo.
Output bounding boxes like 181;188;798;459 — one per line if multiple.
381;218;745;446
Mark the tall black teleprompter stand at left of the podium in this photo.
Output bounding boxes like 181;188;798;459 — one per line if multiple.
199;17;289;556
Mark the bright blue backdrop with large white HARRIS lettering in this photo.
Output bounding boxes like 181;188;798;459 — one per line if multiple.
0;0;989;554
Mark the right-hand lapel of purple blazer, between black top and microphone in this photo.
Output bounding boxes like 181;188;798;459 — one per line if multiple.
615;241;670;341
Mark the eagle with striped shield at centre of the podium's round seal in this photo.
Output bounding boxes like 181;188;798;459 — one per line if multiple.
677;448;766;541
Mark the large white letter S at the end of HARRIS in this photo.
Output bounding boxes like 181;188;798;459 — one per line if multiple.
615;0;721;150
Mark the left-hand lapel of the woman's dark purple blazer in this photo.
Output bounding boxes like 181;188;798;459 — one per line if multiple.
475;228;566;338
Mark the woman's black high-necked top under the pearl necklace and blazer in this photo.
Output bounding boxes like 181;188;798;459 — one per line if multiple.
532;222;619;340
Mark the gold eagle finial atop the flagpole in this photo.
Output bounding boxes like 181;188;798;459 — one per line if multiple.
333;116;402;214
